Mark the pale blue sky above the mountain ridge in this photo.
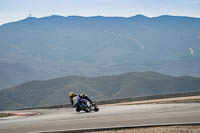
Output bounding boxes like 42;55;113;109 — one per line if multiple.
0;0;200;25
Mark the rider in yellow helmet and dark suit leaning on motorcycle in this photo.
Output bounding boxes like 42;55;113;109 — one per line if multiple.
69;92;95;112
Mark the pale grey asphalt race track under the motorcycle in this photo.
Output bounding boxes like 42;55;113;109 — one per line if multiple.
0;103;200;133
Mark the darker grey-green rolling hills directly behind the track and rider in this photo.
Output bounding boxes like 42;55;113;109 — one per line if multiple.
0;72;200;110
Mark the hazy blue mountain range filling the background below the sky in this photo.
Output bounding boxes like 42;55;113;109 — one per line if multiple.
0;15;200;89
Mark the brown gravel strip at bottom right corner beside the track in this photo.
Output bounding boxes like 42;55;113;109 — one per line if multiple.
88;125;200;133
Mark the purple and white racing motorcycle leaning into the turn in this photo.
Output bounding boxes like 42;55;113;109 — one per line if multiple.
73;96;99;113
